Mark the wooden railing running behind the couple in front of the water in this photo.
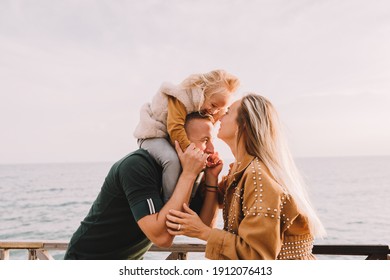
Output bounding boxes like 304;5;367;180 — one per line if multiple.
0;241;390;260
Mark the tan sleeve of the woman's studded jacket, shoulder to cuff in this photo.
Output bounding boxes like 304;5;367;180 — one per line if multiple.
206;161;282;259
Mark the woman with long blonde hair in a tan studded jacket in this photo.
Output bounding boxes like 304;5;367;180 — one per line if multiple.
167;94;324;260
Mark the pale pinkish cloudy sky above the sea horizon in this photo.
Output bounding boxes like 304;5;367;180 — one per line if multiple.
0;0;390;164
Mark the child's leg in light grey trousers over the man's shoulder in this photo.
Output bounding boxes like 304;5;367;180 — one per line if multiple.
139;138;181;202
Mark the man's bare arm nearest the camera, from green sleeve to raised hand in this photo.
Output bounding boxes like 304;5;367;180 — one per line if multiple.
138;142;208;247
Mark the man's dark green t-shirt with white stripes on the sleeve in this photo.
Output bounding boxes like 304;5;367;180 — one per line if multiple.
65;149;163;260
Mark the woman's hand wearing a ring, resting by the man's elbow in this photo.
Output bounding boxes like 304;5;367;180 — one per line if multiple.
166;203;211;241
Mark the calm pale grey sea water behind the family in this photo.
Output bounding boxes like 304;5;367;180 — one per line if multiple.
0;157;390;259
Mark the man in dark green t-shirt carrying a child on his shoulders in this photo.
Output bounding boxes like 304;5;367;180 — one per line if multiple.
65;113;221;260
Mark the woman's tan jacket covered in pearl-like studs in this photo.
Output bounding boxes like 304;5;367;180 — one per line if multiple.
206;152;315;260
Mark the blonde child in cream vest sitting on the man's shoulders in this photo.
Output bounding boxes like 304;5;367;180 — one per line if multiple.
134;70;239;202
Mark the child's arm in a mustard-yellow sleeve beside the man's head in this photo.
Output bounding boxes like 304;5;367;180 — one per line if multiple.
167;97;191;150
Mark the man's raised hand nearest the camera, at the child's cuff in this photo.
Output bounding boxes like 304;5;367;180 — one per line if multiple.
175;141;208;176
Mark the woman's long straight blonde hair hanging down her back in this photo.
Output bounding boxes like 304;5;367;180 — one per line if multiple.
237;93;325;237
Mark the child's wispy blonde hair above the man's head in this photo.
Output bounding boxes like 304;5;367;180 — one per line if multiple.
181;70;240;100
